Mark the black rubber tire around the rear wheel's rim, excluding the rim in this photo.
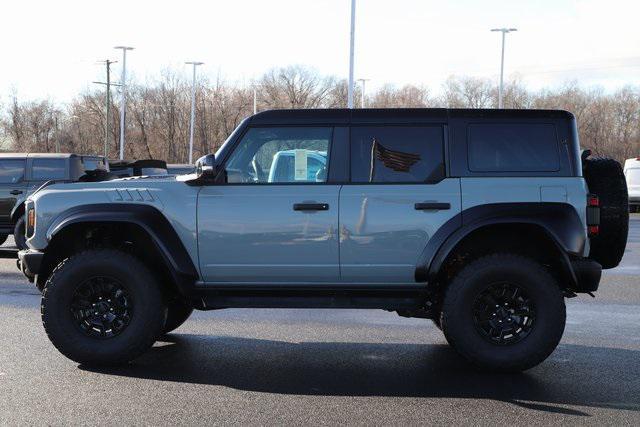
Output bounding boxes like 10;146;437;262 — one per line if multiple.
441;254;566;372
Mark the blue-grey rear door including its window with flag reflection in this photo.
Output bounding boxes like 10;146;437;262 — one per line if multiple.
340;125;461;283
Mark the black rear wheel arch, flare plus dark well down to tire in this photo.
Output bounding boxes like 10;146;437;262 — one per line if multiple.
415;203;586;288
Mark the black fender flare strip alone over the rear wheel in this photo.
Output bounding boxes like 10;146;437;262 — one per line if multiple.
415;202;587;285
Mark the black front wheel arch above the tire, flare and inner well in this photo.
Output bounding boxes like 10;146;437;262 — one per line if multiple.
38;204;199;299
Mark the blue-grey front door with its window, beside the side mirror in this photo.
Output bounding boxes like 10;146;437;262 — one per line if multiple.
198;127;340;284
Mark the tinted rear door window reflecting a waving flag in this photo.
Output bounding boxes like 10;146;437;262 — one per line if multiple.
351;126;445;183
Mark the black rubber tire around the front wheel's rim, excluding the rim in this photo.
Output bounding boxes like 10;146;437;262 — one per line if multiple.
41;249;165;366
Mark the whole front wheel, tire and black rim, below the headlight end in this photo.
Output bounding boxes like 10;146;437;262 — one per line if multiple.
41;249;165;365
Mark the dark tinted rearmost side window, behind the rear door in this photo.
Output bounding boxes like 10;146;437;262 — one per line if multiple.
469;123;560;172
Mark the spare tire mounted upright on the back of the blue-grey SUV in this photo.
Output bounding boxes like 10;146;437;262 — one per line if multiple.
583;157;629;268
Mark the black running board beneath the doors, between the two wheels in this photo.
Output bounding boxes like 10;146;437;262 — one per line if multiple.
193;283;427;310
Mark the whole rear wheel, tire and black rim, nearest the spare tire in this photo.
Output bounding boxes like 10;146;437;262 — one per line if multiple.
441;254;566;372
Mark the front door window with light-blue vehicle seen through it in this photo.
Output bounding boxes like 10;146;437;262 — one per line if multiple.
225;127;333;184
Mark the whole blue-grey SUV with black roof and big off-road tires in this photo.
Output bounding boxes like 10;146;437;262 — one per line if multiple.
19;109;629;371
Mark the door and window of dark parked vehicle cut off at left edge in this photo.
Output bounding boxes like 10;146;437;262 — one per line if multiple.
0;159;27;232
